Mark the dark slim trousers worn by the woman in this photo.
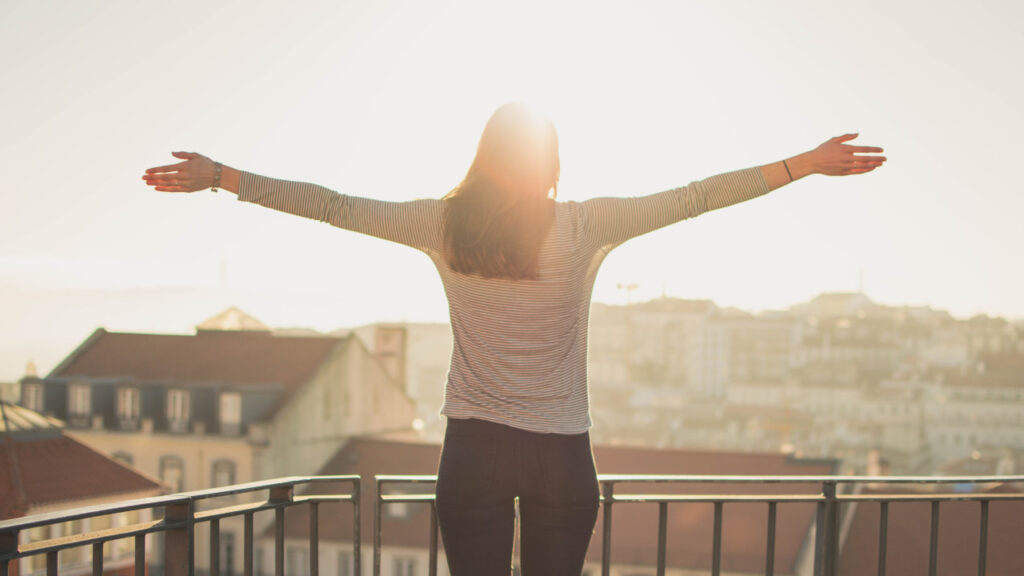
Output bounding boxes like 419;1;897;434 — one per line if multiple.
436;418;599;576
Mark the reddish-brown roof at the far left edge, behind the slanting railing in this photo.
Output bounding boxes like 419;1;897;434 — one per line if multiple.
0;401;162;520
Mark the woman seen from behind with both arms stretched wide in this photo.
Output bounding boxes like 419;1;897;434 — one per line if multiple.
143;104;885;576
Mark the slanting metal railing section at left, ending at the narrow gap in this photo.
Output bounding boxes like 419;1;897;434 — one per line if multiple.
0;476;360;576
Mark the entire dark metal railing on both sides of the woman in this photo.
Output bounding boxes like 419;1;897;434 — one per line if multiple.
0;475;1024;576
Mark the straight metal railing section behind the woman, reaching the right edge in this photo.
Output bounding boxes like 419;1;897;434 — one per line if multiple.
373;475;1024;576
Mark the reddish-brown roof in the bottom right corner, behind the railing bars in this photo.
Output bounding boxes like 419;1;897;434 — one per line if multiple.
839;487;1024;576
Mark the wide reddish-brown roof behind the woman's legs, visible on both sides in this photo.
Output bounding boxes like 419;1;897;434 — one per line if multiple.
272;439;834;573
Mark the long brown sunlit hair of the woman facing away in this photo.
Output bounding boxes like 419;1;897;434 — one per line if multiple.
444;102;559;280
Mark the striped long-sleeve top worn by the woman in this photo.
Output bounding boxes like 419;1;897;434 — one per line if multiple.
239;168;768;434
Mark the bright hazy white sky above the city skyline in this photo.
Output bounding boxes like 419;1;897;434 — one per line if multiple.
0;0;1024;380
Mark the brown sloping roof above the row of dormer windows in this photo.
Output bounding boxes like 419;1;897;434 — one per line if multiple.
49;328;345;389
